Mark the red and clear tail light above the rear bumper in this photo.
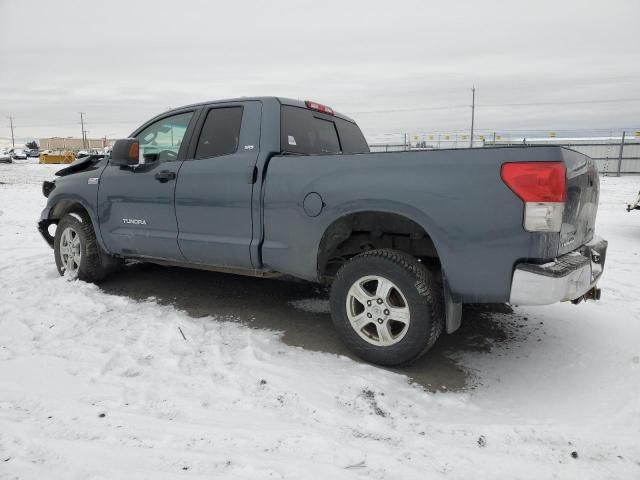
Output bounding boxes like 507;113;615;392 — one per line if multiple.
500;162;567;232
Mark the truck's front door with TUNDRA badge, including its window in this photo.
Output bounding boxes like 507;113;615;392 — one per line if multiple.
98;111;194;260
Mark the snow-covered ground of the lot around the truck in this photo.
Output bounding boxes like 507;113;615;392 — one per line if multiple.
0;164;640;480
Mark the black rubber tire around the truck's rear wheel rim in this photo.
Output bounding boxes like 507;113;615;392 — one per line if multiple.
331;249;444;366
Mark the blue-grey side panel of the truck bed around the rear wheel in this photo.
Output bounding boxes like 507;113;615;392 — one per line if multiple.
262;147;562;302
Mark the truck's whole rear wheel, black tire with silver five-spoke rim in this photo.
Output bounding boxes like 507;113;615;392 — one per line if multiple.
331;249;444;365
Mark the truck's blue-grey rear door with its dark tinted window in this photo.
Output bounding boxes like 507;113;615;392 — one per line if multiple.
176;101;262;268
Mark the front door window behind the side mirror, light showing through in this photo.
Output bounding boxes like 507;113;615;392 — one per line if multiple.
137;112;193;163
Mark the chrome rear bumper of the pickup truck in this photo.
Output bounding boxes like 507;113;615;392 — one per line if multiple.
509;237;607;305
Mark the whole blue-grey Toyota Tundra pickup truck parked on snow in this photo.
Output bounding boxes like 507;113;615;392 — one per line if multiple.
39;97;607;365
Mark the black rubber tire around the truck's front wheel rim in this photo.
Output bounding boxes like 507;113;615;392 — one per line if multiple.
53;212;123;283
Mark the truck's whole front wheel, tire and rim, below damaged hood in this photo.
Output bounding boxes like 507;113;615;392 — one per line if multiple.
53;213;122;282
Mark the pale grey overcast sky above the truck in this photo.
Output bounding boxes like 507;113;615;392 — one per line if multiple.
0;0;640;143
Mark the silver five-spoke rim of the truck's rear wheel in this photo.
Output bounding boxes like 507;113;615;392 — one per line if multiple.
346;275;411;347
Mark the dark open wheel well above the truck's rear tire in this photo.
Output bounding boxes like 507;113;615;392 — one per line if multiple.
318;212;440;280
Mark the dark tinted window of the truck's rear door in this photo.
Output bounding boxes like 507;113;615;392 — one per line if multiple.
195;107;242;159
